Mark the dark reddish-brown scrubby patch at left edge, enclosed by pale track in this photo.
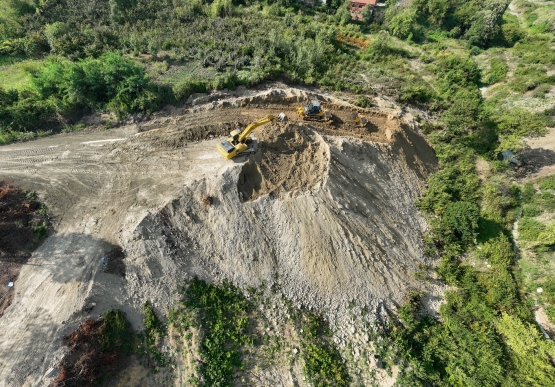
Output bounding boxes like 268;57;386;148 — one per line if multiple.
0;180;47;317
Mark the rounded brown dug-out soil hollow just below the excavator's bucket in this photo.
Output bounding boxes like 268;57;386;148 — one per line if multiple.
237;124;329;201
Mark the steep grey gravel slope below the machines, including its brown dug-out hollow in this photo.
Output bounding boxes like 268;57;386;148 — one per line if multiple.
121;119;434;332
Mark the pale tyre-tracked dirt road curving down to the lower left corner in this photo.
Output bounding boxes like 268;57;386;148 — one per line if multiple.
0;121;239;386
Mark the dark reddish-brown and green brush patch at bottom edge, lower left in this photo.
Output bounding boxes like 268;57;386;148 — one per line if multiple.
52;310;135;387
